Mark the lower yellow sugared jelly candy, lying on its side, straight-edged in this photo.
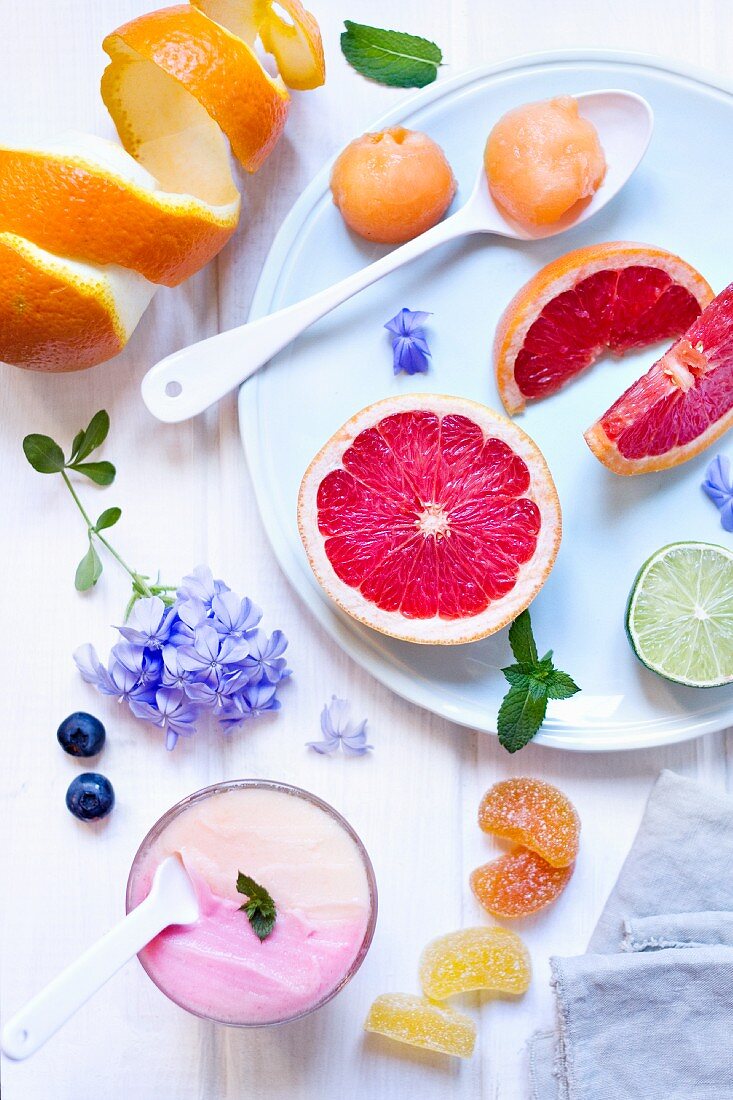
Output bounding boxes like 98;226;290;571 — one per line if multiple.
364;993;475;1058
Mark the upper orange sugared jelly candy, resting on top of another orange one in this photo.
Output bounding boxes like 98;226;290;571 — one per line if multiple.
479;778;580;867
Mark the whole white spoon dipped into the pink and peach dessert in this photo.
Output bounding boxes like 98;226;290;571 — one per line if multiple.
0;856;199;1062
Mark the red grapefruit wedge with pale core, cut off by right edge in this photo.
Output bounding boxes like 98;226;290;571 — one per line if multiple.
586;284;733;474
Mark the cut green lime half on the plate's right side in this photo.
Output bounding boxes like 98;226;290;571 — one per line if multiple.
626;542;733;688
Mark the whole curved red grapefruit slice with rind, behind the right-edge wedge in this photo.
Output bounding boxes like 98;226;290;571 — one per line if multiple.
494;241;713;414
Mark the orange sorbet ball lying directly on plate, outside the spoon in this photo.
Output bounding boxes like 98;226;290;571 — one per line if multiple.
331;127;456;244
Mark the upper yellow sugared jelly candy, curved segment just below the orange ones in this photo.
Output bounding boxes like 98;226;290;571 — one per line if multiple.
420;924;532;1001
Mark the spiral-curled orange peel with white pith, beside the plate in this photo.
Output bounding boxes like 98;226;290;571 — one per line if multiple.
0;0;325;371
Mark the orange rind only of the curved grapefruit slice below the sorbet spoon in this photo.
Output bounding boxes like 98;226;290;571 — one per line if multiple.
493;241;714;416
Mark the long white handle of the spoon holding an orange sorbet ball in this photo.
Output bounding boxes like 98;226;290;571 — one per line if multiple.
141;201;479;424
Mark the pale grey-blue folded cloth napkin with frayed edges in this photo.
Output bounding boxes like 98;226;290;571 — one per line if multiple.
529;771;733;1100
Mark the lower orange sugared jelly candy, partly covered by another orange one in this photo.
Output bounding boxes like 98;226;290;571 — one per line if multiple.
469;848;575;917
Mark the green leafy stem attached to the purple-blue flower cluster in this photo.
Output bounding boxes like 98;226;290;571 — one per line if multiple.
23;409;175;618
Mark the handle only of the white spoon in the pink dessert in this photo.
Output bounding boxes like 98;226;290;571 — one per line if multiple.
0;894;169;1062
